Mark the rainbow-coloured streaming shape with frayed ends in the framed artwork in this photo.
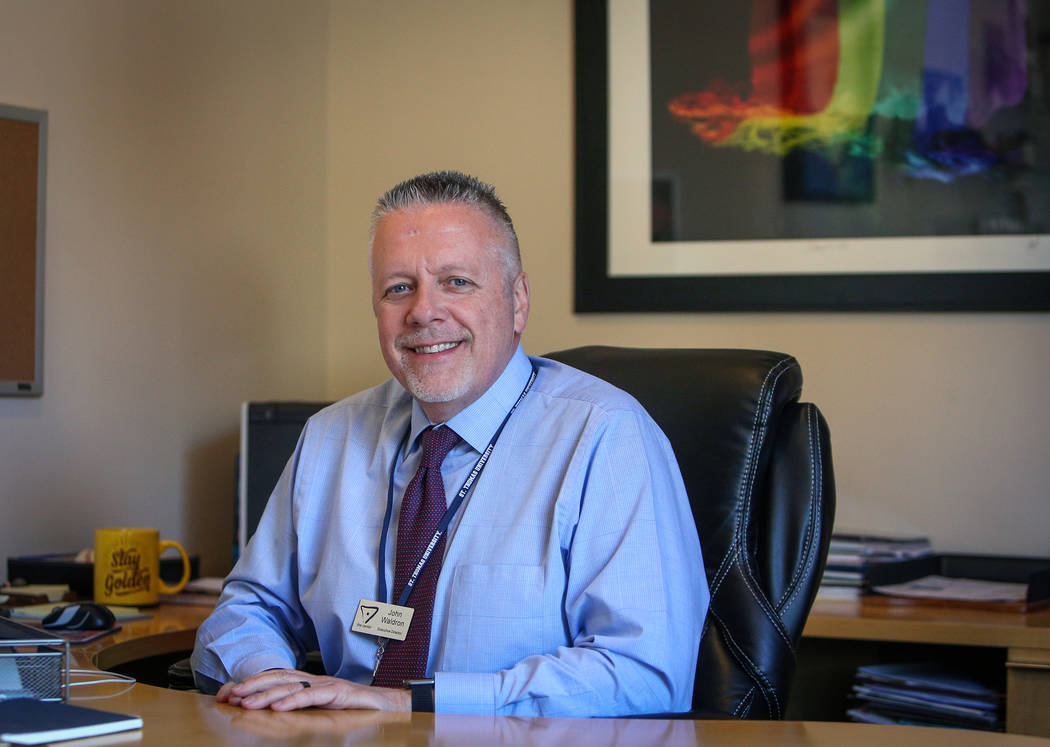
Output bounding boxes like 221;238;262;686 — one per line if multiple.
668;0;1024;182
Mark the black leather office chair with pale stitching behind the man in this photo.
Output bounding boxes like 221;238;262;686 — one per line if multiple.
547;347;835;719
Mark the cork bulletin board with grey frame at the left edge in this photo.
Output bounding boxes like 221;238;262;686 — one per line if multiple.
0;104;47;396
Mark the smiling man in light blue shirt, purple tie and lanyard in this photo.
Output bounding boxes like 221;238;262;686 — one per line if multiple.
192;172;708;715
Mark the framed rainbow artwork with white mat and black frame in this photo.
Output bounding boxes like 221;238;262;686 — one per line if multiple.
575;0;1050;312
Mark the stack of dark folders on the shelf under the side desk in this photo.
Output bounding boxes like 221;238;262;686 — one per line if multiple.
847;663;1003;731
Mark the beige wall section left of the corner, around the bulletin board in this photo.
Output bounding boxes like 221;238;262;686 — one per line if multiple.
0;0;327;573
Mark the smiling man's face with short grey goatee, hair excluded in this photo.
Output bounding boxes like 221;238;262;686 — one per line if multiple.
372;204;528;422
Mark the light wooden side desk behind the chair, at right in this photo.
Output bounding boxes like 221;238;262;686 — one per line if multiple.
796;600;1050;736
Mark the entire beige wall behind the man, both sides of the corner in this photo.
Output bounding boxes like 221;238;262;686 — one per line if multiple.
0;0;1050;573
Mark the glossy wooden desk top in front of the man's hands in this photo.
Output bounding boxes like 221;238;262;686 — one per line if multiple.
74;684;1050;747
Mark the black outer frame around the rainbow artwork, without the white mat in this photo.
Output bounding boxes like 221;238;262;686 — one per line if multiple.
574;0;1050;313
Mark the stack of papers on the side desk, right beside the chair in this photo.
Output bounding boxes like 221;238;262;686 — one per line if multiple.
817;532;933;599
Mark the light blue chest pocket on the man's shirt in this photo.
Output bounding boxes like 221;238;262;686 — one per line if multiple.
444;565;550;671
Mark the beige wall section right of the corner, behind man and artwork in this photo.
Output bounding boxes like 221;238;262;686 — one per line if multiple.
328;0;1050;556
